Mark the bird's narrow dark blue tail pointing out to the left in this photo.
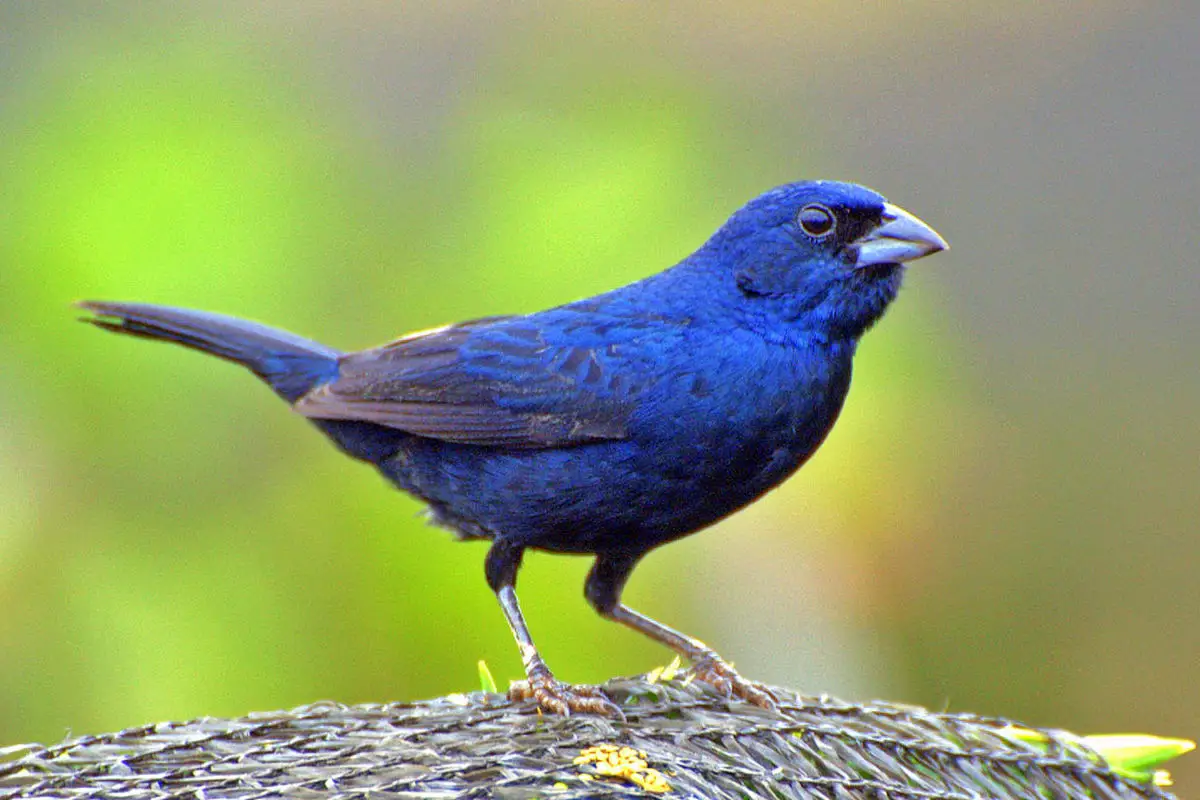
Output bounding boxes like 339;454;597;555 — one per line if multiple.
78;301;341;403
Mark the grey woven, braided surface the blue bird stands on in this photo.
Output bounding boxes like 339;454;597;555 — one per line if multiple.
0;678;1171;800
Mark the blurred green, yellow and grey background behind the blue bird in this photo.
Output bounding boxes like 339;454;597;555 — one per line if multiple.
0;0;1200;786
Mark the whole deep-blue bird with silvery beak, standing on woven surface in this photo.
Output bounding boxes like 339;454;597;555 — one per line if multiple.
77;180;948;716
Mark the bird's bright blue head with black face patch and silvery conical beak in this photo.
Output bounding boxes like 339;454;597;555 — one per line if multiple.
696;181;947;338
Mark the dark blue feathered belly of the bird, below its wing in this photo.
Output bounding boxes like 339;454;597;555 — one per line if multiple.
383;388;836;553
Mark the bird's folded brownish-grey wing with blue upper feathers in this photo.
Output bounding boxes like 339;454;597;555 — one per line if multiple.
295;317;648;449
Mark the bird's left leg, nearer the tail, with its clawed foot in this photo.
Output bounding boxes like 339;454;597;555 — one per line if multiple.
485;540;623;717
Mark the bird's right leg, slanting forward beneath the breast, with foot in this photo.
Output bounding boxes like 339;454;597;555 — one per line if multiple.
584;554;775;709
